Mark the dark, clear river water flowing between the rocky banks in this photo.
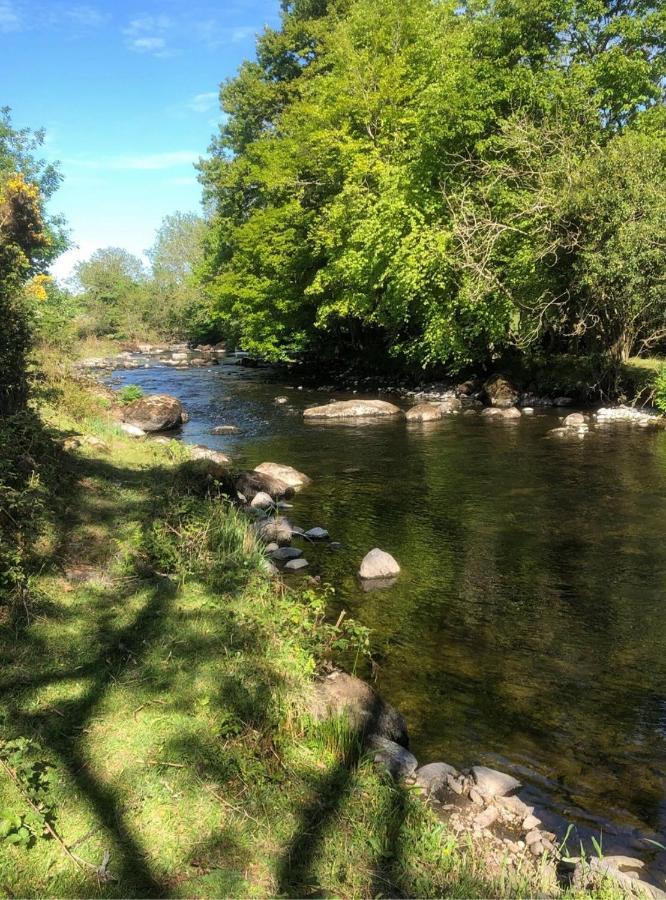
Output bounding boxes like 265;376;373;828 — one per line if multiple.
109;356;666;863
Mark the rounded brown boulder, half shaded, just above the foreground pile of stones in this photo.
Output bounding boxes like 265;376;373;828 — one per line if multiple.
309;670;409;747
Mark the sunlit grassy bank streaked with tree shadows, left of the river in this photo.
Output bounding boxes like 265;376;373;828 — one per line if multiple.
0;356;616;897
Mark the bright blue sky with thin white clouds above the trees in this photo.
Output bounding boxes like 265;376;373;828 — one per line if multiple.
0;0;279;277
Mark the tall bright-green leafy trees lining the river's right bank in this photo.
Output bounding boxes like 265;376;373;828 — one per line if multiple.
201;0;666;371
